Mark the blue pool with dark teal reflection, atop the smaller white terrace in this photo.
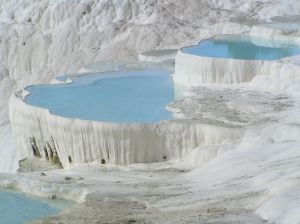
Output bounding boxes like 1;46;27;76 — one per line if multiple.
181;35;300;61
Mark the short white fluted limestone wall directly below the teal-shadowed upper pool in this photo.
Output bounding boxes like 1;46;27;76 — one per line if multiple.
174;51;288;87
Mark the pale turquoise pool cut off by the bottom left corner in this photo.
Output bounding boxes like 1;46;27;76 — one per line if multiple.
0;190;71;224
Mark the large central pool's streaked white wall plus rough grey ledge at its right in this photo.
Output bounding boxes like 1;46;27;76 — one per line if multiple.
10;71;291;171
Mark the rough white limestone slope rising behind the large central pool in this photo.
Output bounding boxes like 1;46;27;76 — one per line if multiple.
0;0;255;172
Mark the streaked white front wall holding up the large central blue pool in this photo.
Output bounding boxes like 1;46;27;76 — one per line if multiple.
10;91;243;167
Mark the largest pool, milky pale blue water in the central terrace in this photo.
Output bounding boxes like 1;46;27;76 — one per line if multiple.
25;69;175;123
